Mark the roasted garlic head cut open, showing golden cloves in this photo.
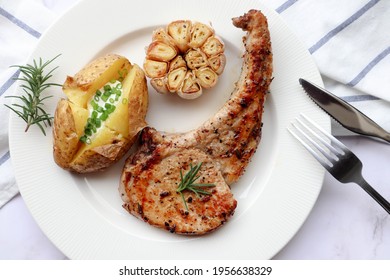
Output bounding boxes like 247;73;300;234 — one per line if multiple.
143;20;226;99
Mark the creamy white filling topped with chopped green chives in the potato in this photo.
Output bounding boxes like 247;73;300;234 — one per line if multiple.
80;80;127;144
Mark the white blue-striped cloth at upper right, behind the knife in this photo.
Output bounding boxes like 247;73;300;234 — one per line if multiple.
263;0;390;136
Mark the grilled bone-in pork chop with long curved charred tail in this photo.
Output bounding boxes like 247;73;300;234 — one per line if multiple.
120;10;272;235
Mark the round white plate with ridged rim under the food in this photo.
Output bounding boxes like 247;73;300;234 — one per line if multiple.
10;0;330;259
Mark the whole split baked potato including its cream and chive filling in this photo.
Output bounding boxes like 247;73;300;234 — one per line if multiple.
53;54;148;173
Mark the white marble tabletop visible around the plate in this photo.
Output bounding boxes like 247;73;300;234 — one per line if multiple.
0;0;390;260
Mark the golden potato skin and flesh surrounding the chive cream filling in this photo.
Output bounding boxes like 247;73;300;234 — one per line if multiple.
53;54;148;173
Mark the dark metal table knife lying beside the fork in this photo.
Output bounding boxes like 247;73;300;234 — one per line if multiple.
299;78;390;143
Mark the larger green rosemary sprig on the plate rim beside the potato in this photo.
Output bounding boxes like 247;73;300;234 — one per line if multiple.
5;55;61;135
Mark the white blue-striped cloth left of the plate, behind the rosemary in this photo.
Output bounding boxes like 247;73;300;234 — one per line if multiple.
0;0;68;208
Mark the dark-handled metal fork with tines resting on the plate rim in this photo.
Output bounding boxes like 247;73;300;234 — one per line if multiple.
288;114;390;214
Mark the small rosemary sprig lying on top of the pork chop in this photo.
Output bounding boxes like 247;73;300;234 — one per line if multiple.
176;162;215;211
